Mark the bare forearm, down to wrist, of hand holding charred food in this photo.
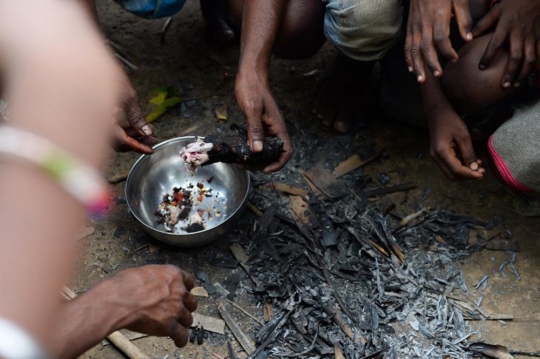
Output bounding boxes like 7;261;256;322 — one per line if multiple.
239;0;288;74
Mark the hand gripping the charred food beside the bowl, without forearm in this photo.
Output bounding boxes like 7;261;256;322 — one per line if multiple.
235;71;293;173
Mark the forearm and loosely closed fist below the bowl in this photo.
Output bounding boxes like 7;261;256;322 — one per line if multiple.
50;265;197;359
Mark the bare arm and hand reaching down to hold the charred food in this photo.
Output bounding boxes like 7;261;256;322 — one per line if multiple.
235;0;293;172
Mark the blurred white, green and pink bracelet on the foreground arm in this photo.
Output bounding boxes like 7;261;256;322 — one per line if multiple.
0;125;111;217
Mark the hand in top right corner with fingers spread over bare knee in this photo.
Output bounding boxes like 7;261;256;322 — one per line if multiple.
473;0;540;88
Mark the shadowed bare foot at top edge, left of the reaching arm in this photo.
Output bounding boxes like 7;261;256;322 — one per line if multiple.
200;0;237;44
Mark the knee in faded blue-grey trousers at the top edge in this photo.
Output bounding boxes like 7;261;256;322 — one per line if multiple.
324;0;403;61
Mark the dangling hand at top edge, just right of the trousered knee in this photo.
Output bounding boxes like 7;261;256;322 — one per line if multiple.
405;0;473;83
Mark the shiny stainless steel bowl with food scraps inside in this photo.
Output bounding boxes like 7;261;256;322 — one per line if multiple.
126;136;249;247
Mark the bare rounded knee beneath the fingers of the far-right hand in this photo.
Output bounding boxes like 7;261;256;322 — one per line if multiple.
442;36;514;112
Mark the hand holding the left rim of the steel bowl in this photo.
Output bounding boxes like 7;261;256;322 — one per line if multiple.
113;75;157;154
